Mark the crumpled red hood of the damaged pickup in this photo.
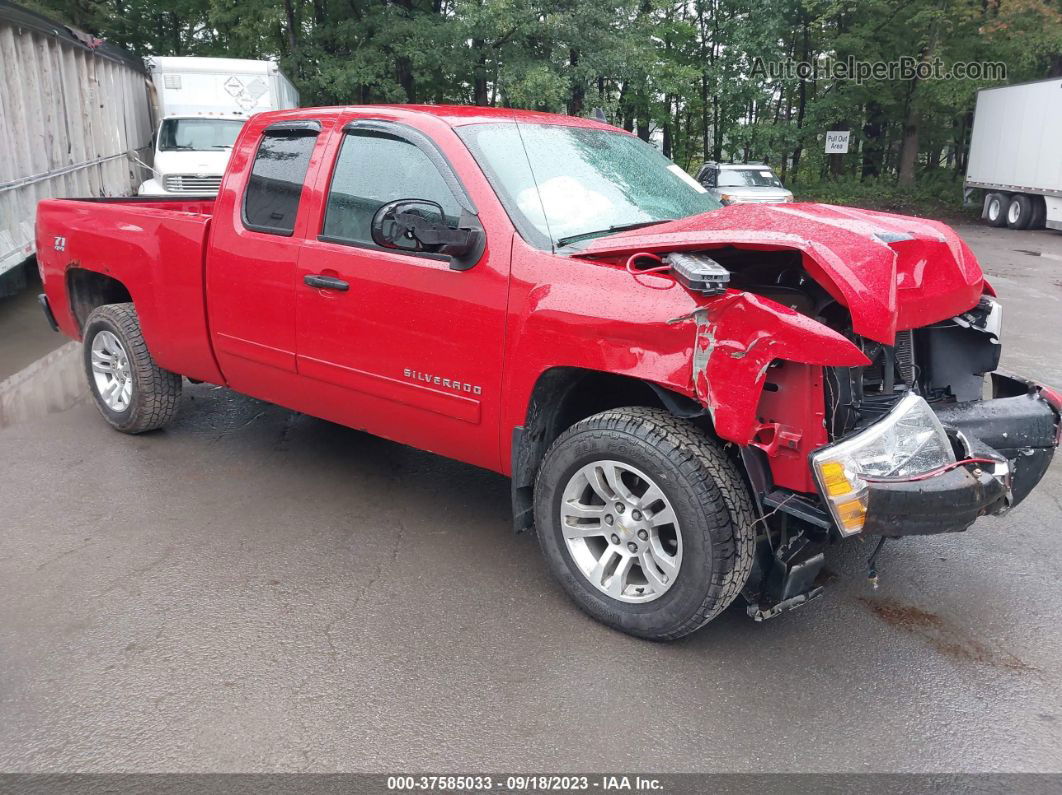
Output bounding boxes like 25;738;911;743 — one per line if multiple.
578;204;984;345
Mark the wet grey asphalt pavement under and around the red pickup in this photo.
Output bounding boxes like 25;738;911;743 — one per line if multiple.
0;221;1062;773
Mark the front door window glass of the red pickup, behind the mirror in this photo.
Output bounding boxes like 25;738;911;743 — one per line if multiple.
322;131;461;245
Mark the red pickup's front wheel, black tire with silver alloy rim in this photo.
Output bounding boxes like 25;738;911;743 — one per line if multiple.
534;407;755;640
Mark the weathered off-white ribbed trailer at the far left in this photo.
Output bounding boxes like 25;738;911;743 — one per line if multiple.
0;0;152;296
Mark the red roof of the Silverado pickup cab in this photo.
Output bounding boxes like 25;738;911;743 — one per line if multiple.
248;105;626;133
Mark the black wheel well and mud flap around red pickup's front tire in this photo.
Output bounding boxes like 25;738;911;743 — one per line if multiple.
512;367;710;532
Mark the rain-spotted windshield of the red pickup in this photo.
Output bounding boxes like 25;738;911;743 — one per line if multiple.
458;122;721;248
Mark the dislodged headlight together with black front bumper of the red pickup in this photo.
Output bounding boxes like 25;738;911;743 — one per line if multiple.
811;373;1059;537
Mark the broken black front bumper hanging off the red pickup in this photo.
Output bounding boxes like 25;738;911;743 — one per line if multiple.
862;374;1060;536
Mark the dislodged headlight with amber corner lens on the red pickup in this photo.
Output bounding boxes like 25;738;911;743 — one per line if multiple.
811;394;956;536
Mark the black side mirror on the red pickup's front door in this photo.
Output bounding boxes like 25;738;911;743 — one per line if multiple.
371;198;483;270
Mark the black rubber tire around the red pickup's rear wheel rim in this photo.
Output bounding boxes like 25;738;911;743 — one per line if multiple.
83;304;182;433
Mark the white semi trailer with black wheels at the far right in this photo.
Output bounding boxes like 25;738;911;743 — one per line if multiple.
965;77;1062;230
